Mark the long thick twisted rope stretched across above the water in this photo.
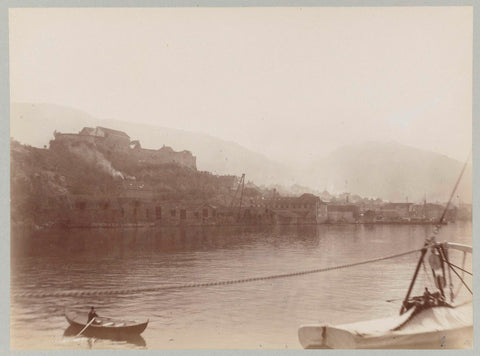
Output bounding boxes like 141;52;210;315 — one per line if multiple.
12;249;421;298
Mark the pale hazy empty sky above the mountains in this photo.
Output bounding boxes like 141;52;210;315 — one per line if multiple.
10;6;473;161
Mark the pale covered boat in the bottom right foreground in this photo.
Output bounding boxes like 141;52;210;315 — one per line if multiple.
298;303;473;349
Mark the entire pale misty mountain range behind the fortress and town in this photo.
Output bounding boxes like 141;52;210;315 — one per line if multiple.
11;103;472;203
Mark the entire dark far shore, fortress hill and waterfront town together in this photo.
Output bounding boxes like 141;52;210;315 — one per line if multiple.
11;127;471;229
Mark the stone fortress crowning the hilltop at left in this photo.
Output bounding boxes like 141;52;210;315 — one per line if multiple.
50;126;197;170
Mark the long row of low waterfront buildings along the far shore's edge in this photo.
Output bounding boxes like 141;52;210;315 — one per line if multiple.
39;181;464;227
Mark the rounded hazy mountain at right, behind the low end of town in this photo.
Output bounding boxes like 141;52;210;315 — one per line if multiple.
302;142;472;203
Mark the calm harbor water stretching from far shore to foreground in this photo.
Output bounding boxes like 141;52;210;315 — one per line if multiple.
10;223;472;349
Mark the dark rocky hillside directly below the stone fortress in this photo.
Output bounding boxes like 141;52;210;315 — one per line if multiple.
10;140;235;226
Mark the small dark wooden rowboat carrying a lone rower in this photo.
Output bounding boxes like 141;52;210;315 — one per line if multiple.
65;310;148;338
